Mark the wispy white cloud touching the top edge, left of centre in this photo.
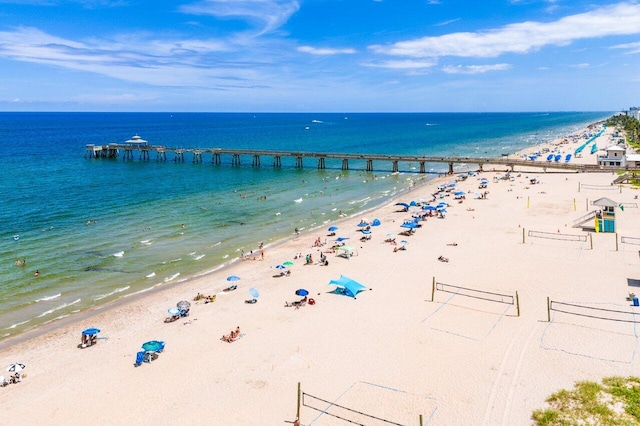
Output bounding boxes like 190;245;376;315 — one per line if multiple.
180;0;300;34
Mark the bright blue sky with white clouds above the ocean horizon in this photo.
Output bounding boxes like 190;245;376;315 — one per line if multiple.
0;0;640;112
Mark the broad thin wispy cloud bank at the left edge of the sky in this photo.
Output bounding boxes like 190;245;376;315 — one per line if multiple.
0;28;261;87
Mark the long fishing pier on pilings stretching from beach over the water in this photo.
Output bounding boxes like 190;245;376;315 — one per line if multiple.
85;136;602;174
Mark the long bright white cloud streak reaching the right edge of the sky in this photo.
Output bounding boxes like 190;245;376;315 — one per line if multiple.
369;3;640;58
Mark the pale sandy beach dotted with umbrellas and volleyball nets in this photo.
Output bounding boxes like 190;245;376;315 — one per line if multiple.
0;125;640;426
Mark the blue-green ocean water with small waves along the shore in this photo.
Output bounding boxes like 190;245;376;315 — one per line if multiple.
0;112;612;339
